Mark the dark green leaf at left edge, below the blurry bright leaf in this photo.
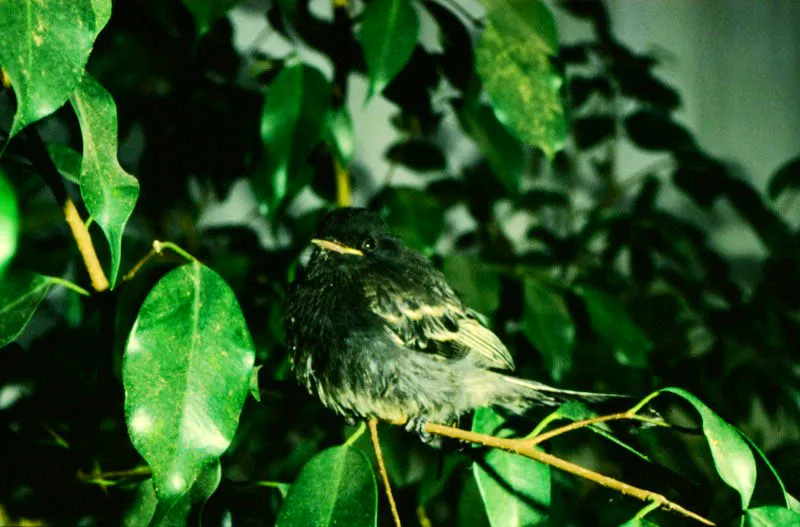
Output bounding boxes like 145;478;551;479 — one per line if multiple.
0;273;53;348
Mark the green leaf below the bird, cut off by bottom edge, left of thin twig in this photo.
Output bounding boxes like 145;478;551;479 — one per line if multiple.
275;446;378;527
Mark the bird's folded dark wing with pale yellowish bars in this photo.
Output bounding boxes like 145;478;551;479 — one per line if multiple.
365;281;514;370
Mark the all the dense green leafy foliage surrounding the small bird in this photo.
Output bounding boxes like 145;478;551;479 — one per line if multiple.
0;0;800;527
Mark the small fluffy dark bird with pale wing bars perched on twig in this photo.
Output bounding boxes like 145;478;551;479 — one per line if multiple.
285;208;644;436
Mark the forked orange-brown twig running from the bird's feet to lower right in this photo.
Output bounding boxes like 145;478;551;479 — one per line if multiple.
392;418;716;525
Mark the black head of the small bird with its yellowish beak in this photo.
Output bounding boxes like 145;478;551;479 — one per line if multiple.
311;207;402;265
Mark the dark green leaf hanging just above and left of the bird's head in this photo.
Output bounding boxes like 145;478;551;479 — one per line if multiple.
256;63;331;207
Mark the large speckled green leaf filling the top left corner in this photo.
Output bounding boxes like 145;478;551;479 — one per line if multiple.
0;0;99;137
